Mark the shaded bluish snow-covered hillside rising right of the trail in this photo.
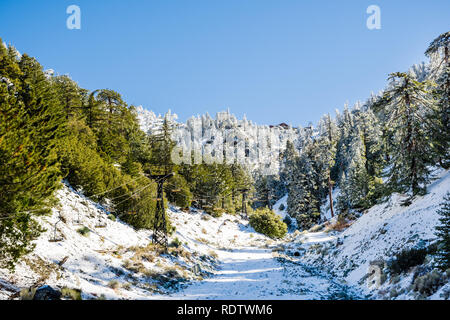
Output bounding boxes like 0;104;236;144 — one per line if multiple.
287;170;450;299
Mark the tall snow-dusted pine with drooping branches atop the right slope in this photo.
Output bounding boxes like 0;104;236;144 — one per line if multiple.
380;72;434;195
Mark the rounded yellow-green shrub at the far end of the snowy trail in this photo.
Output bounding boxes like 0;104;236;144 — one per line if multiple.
250;208;287;238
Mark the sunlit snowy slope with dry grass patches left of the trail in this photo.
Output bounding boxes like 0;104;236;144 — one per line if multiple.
0;185;224;299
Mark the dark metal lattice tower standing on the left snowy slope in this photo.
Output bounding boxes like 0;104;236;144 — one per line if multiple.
149;173;173;247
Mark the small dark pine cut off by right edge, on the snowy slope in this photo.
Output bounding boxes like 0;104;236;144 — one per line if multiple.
436;192;450;270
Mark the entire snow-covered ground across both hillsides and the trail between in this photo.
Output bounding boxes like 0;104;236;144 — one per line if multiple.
0;171;450;299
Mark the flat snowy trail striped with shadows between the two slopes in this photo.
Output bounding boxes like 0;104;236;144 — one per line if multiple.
169;247;357;300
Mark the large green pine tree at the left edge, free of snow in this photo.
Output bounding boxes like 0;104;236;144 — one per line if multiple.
0;49;64;268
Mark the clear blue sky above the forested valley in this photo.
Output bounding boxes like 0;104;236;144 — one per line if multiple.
0;0;450;125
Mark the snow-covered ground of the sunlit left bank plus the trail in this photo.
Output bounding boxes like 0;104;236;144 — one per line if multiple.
0;185;362;299
